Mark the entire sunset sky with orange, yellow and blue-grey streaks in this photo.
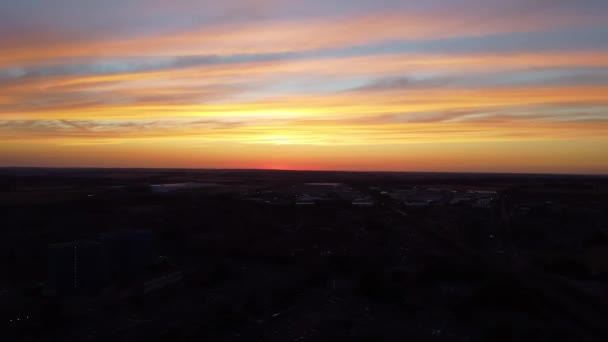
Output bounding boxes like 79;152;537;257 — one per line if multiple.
0;0;608;174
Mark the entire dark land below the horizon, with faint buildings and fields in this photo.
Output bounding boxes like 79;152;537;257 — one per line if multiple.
0;169;608;342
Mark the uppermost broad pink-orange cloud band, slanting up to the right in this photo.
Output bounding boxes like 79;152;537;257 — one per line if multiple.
0;4;603;65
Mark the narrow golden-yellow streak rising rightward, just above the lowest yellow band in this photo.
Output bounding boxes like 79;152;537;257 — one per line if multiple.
3;86;608;121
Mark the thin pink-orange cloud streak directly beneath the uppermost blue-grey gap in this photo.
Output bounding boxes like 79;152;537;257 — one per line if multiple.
0;50;608;90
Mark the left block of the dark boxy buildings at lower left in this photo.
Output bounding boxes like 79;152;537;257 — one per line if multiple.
48;241;106;295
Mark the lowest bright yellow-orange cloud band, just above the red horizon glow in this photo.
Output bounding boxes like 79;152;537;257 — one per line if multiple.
0;104;608;145
